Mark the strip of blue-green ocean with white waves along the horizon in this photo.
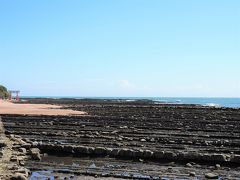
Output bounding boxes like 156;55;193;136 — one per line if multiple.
22;96;240;108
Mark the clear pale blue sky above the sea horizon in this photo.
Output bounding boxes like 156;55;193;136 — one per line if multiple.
0;0;240;97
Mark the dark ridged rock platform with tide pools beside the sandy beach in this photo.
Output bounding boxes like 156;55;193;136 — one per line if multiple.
0;99;240;179
